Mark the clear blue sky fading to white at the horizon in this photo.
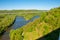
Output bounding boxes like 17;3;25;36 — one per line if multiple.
0;0;60;10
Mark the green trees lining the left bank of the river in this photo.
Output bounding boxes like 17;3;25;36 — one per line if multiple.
0;14;15;34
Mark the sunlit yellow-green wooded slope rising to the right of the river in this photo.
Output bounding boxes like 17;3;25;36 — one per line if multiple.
10;7;60;40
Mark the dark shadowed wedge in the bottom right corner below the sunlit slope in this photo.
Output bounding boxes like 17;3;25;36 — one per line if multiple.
37;28;60;40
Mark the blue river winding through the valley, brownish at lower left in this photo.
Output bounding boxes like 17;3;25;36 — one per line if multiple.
0;16;39;40
